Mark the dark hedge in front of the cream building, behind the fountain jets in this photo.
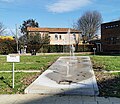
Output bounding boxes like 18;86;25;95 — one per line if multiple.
27;44;95;53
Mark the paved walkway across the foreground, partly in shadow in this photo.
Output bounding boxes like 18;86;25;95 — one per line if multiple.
0;94;120;104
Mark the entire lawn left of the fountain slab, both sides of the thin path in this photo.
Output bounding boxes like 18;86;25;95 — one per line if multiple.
0;55;62;94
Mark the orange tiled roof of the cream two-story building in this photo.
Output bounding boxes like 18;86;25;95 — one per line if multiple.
27;27;80;33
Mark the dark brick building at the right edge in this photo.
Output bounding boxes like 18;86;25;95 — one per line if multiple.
101;20;120;52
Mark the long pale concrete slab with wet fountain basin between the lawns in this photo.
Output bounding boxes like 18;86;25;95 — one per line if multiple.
25;56;99;95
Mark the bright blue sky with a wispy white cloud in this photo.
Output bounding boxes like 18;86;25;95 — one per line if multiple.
0;0;120;35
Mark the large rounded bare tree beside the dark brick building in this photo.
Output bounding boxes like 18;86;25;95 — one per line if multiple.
74;11;102;42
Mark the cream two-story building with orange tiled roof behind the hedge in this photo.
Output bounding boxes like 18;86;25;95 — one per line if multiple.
27;27;82;45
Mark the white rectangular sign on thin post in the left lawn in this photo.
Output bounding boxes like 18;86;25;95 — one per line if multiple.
7;55;20;88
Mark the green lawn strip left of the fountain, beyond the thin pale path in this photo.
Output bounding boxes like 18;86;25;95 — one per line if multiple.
0;55;58;71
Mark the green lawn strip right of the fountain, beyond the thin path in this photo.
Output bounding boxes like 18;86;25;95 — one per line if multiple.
91;56;120;71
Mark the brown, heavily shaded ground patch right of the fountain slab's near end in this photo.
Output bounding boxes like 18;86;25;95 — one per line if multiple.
95;71;120;97
